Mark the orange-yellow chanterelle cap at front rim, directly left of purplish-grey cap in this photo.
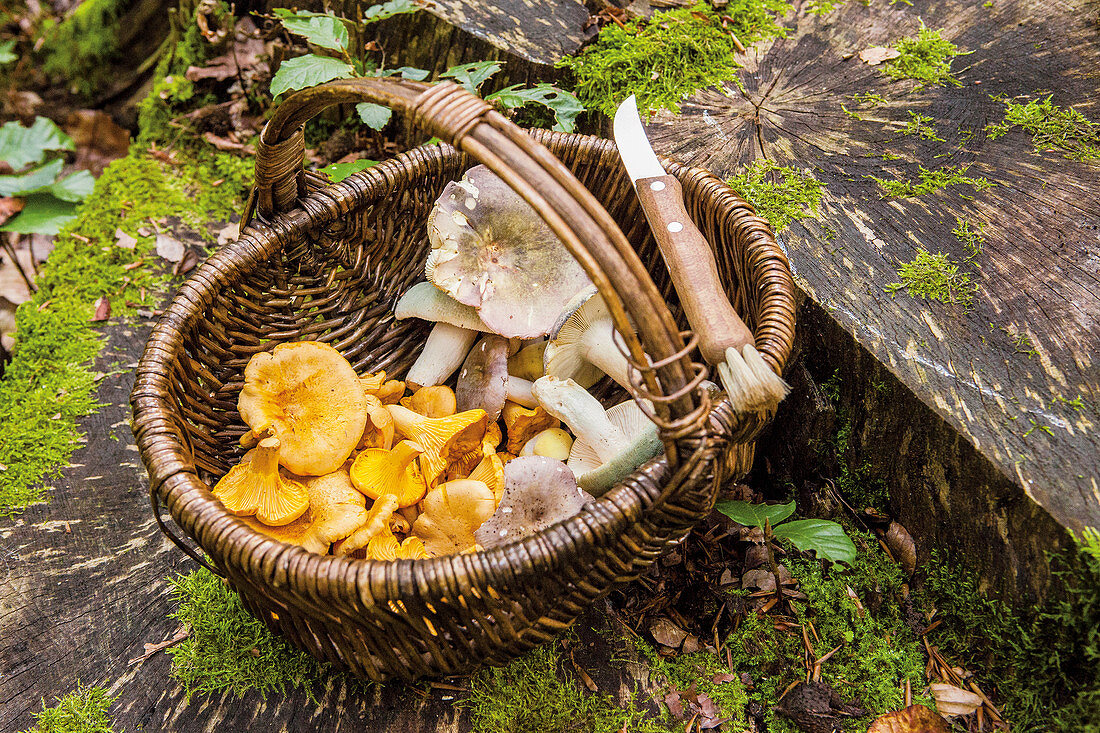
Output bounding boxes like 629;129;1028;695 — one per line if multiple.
413;479;496;556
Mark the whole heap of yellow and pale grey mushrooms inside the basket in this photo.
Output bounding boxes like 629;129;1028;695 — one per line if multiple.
215;166;661;559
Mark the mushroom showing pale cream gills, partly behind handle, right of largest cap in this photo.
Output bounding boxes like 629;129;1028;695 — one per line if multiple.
542;292;629;389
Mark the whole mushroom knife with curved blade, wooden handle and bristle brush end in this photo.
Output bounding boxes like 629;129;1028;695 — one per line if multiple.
614;95;788;411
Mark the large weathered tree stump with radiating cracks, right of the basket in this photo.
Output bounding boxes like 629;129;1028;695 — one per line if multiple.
649;0;1100;591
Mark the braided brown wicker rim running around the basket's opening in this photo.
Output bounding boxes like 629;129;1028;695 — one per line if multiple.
131;130;794;601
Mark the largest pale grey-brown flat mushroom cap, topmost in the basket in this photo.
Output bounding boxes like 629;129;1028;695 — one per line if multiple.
425;165;592;338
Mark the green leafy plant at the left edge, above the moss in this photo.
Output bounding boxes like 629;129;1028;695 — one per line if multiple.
0;117;96;234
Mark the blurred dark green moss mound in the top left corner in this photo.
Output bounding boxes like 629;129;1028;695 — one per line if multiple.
43;0;127;97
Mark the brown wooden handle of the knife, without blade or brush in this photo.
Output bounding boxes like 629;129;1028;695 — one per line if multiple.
636;175;754;364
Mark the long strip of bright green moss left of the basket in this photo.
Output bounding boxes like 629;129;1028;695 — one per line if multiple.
0;153;250;516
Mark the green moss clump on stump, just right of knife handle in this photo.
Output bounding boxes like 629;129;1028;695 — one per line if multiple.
726;161;825;232
